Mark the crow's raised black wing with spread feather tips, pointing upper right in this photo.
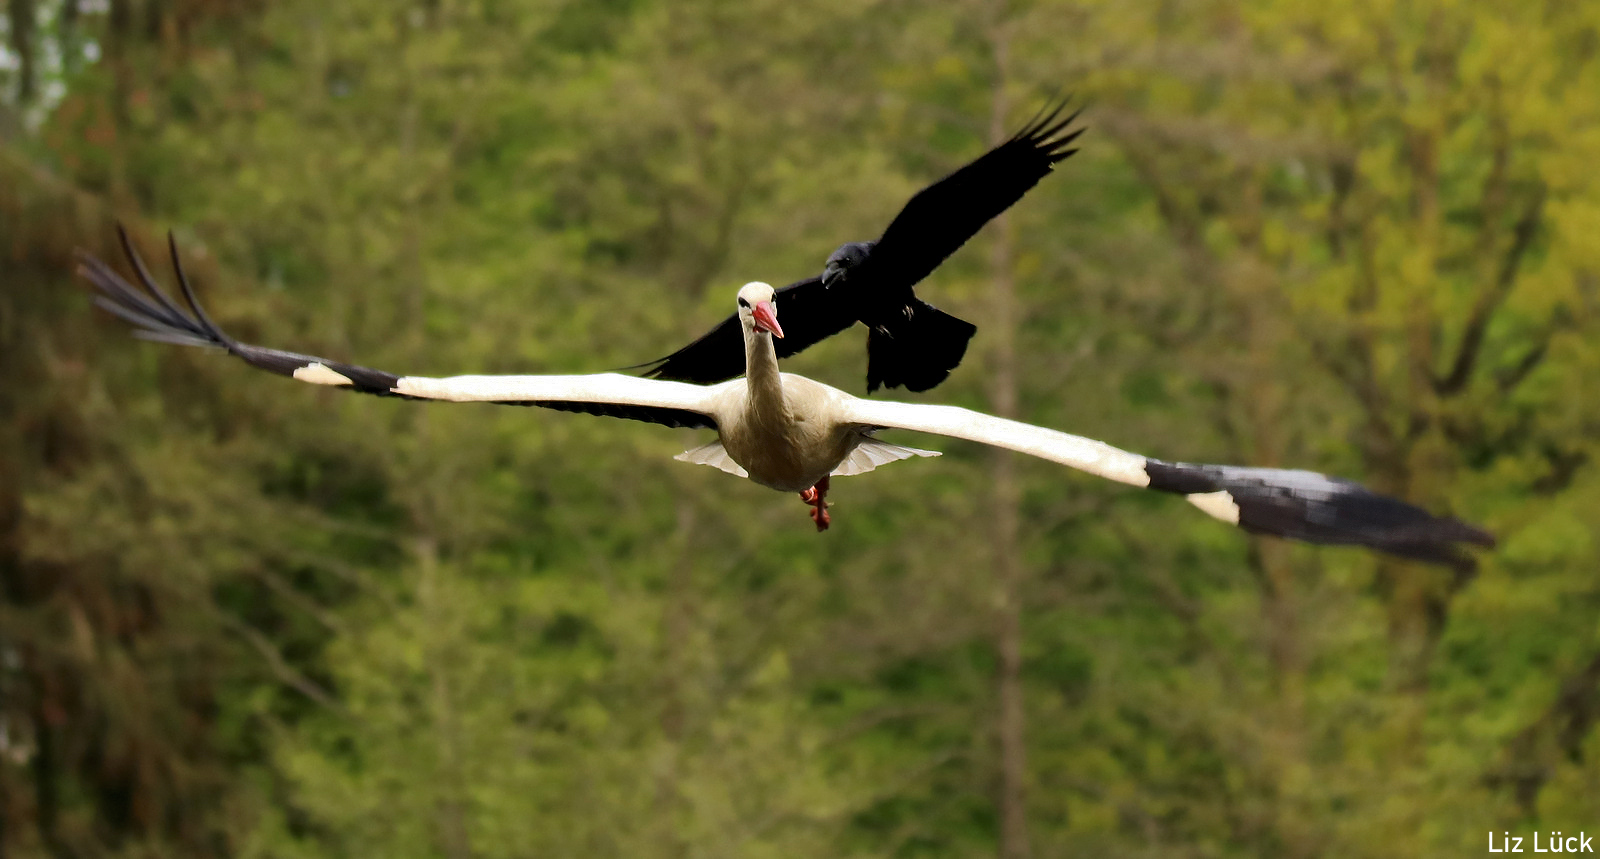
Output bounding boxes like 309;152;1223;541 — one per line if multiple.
850;101;1083;291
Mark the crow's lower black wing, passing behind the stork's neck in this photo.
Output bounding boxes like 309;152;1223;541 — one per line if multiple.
640;277;856;386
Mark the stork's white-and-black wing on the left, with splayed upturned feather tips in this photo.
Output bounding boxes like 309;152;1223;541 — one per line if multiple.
78;227;717;429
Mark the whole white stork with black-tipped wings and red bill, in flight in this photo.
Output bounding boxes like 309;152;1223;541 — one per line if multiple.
78;225;1494;568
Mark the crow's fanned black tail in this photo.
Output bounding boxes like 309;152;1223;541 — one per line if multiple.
867;299;978;394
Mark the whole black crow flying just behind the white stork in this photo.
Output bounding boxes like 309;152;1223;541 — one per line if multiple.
629;101;1083;394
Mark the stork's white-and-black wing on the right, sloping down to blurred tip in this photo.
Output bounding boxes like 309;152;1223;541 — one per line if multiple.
842;397;1494;569
